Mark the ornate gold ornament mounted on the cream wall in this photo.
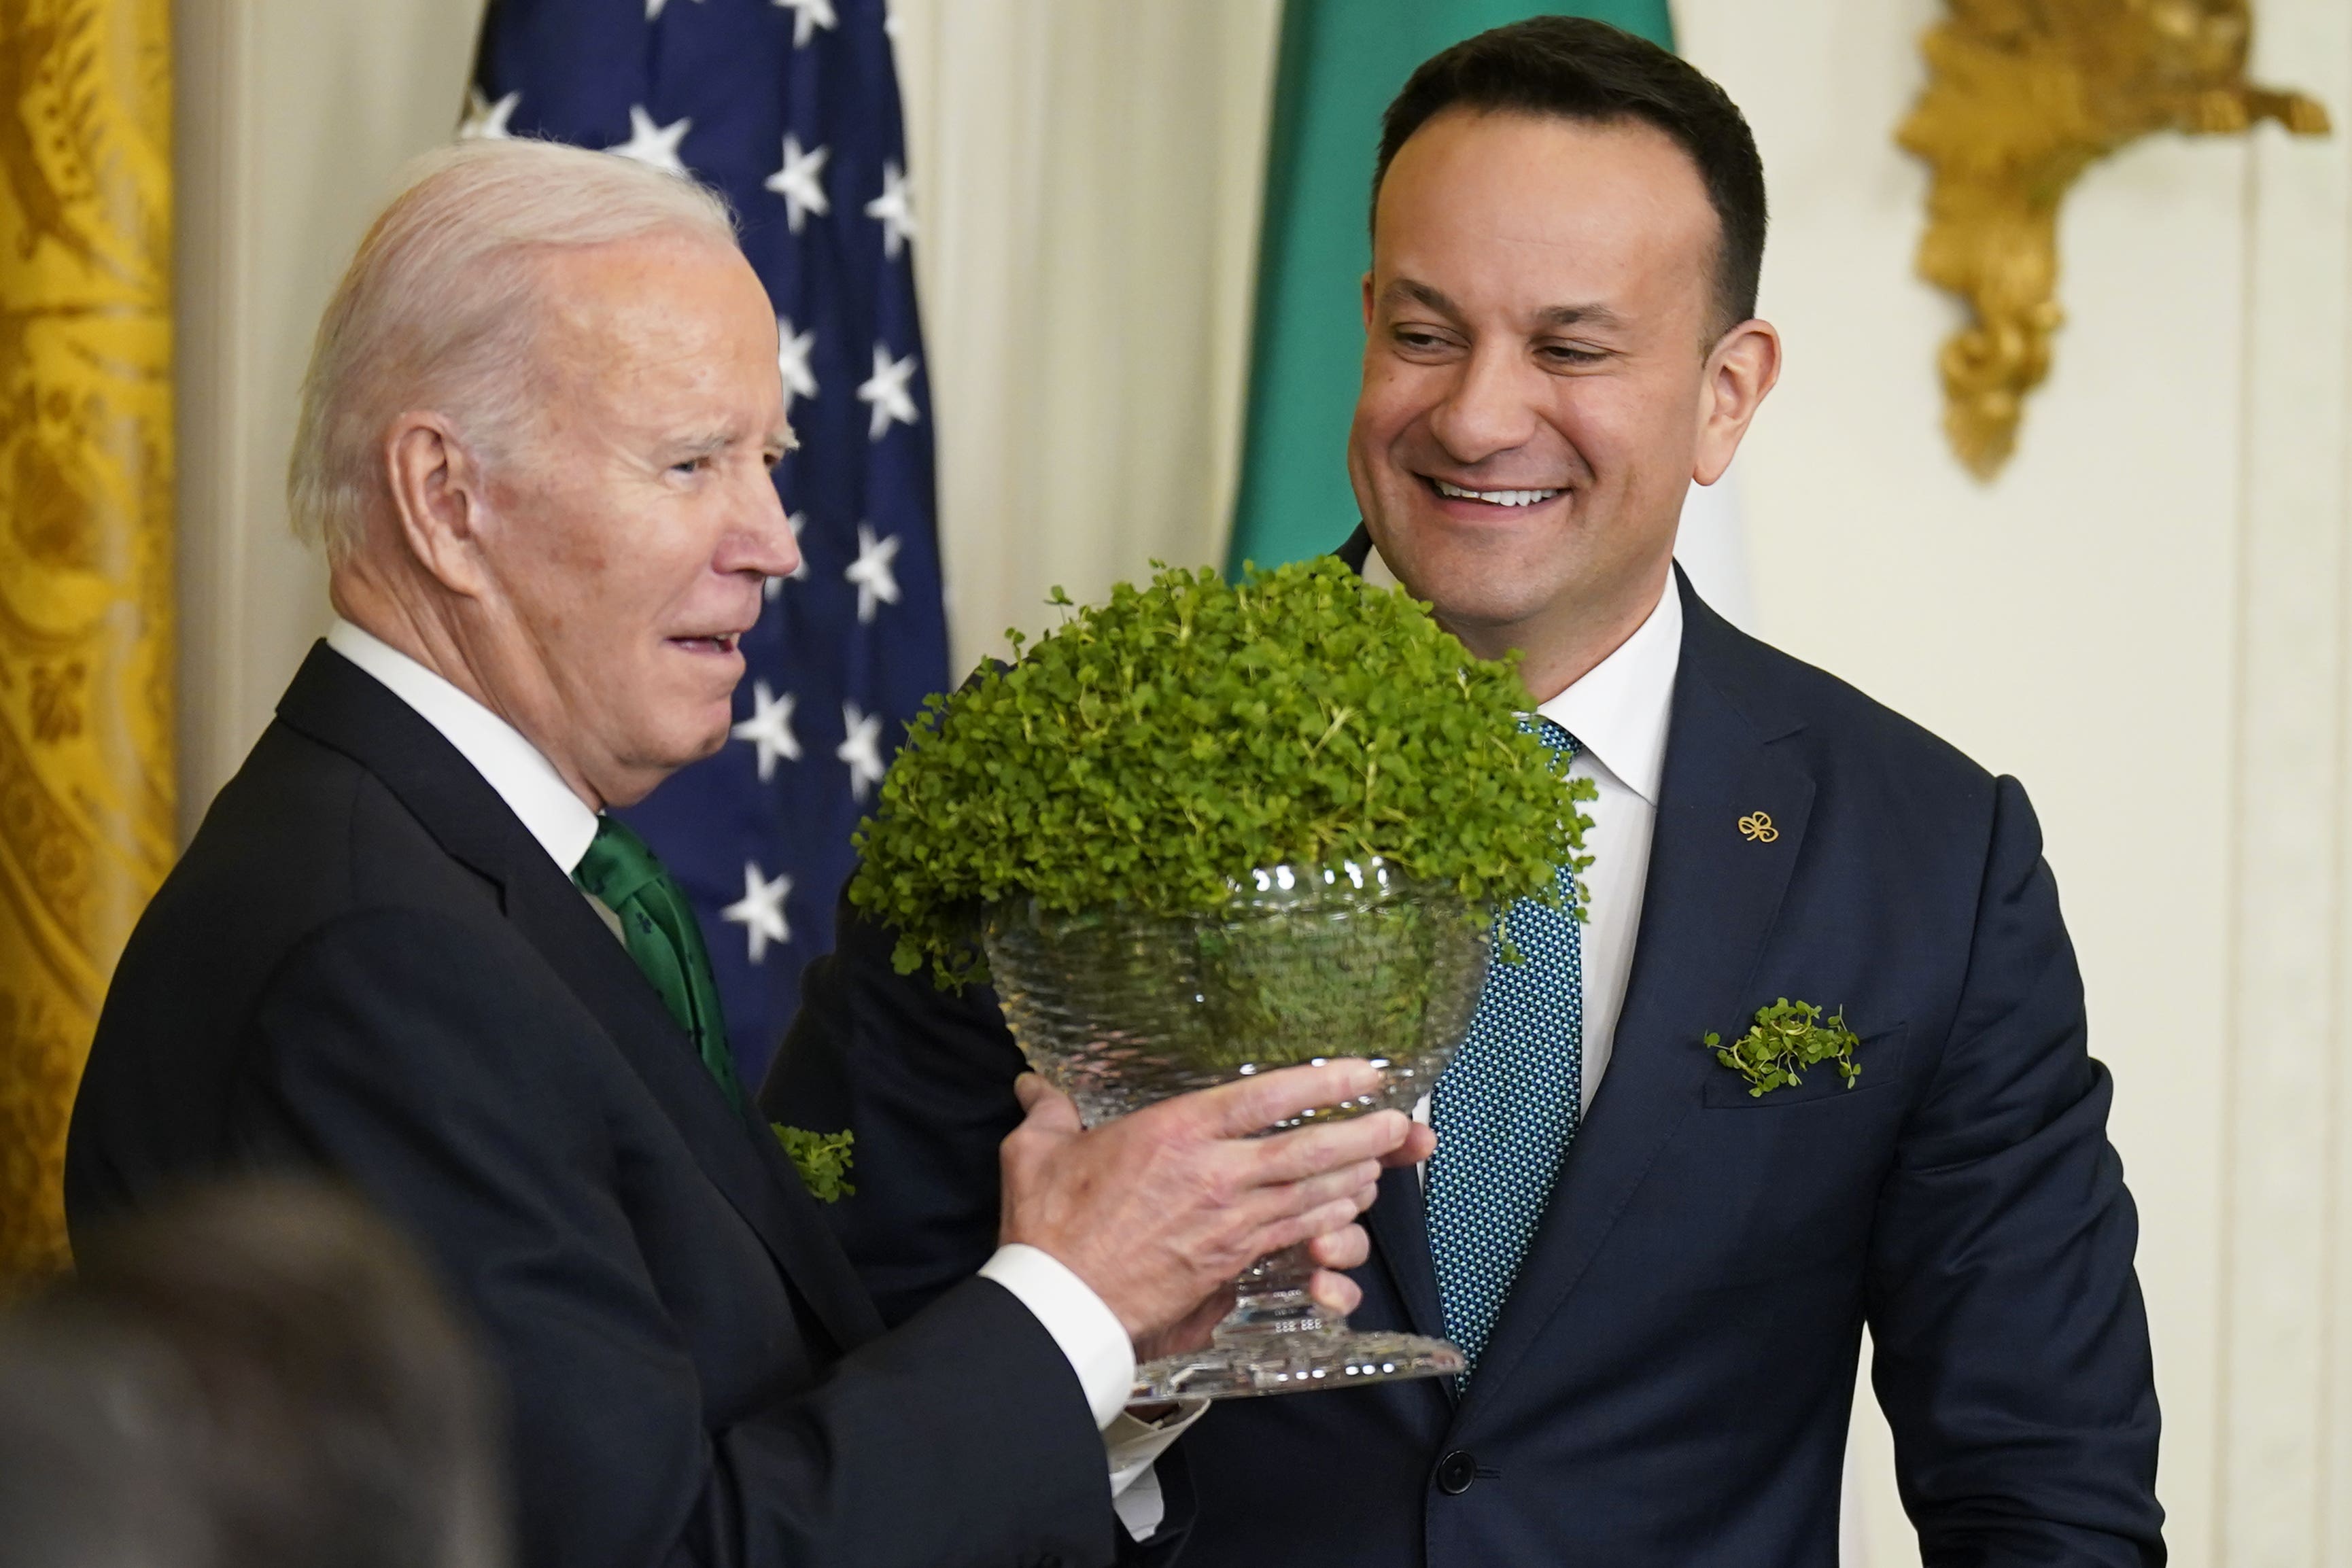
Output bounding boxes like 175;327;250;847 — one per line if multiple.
1896;0;2328;480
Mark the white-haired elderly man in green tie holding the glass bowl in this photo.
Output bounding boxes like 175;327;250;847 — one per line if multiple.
66;143;1428;1568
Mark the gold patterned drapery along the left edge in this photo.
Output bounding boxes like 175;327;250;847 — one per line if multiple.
0;0;174;1286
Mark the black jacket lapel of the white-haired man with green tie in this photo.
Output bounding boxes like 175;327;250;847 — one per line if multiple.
277;644;882;1349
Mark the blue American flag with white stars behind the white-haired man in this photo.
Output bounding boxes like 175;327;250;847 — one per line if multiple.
461;0;948;1083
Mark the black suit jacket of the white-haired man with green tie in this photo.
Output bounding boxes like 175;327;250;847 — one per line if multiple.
66;646;1183;1568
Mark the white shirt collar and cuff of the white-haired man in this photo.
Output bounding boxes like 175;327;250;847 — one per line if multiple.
327;616;1197;1539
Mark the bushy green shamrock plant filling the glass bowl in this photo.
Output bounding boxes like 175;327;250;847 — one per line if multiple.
849;557;1592;988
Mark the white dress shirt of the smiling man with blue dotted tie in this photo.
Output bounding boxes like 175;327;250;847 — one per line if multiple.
1364;550;1682;1121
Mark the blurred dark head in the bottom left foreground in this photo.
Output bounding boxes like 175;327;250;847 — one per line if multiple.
0;1180;506;1568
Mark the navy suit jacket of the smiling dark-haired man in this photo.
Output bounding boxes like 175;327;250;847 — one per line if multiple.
765;564;2164;1568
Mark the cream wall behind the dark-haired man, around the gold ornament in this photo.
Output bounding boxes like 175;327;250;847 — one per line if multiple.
1675;0;2352;1568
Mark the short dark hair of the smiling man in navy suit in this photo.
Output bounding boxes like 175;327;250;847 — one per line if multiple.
1371;16;1764;332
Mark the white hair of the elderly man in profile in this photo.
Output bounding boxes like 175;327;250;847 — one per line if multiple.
287;139;736;562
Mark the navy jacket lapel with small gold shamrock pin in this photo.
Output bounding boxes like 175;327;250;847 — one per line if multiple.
1423;585;1814;1420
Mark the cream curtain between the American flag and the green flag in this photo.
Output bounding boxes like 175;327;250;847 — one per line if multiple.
891;0;1282;675
